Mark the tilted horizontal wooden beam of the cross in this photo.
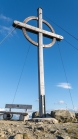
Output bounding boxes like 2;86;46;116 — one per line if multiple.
13;20;63;40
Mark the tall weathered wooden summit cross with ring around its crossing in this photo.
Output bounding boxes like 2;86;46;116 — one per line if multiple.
13;8;63;117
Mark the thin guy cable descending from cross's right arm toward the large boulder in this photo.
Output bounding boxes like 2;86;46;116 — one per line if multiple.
57;42;75;111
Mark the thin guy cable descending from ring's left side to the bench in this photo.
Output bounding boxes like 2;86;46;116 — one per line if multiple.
12;45;30;104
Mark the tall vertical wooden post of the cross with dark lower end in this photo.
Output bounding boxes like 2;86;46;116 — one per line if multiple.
38;8;45;117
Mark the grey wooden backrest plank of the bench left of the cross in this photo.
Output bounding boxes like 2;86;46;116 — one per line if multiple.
5;104;32;109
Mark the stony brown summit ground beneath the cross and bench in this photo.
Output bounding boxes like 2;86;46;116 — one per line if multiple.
0;111;78;139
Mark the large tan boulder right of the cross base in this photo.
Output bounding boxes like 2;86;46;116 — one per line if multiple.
51;110;76;123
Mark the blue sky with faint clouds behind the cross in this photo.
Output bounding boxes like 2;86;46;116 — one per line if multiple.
0;0;78;110
